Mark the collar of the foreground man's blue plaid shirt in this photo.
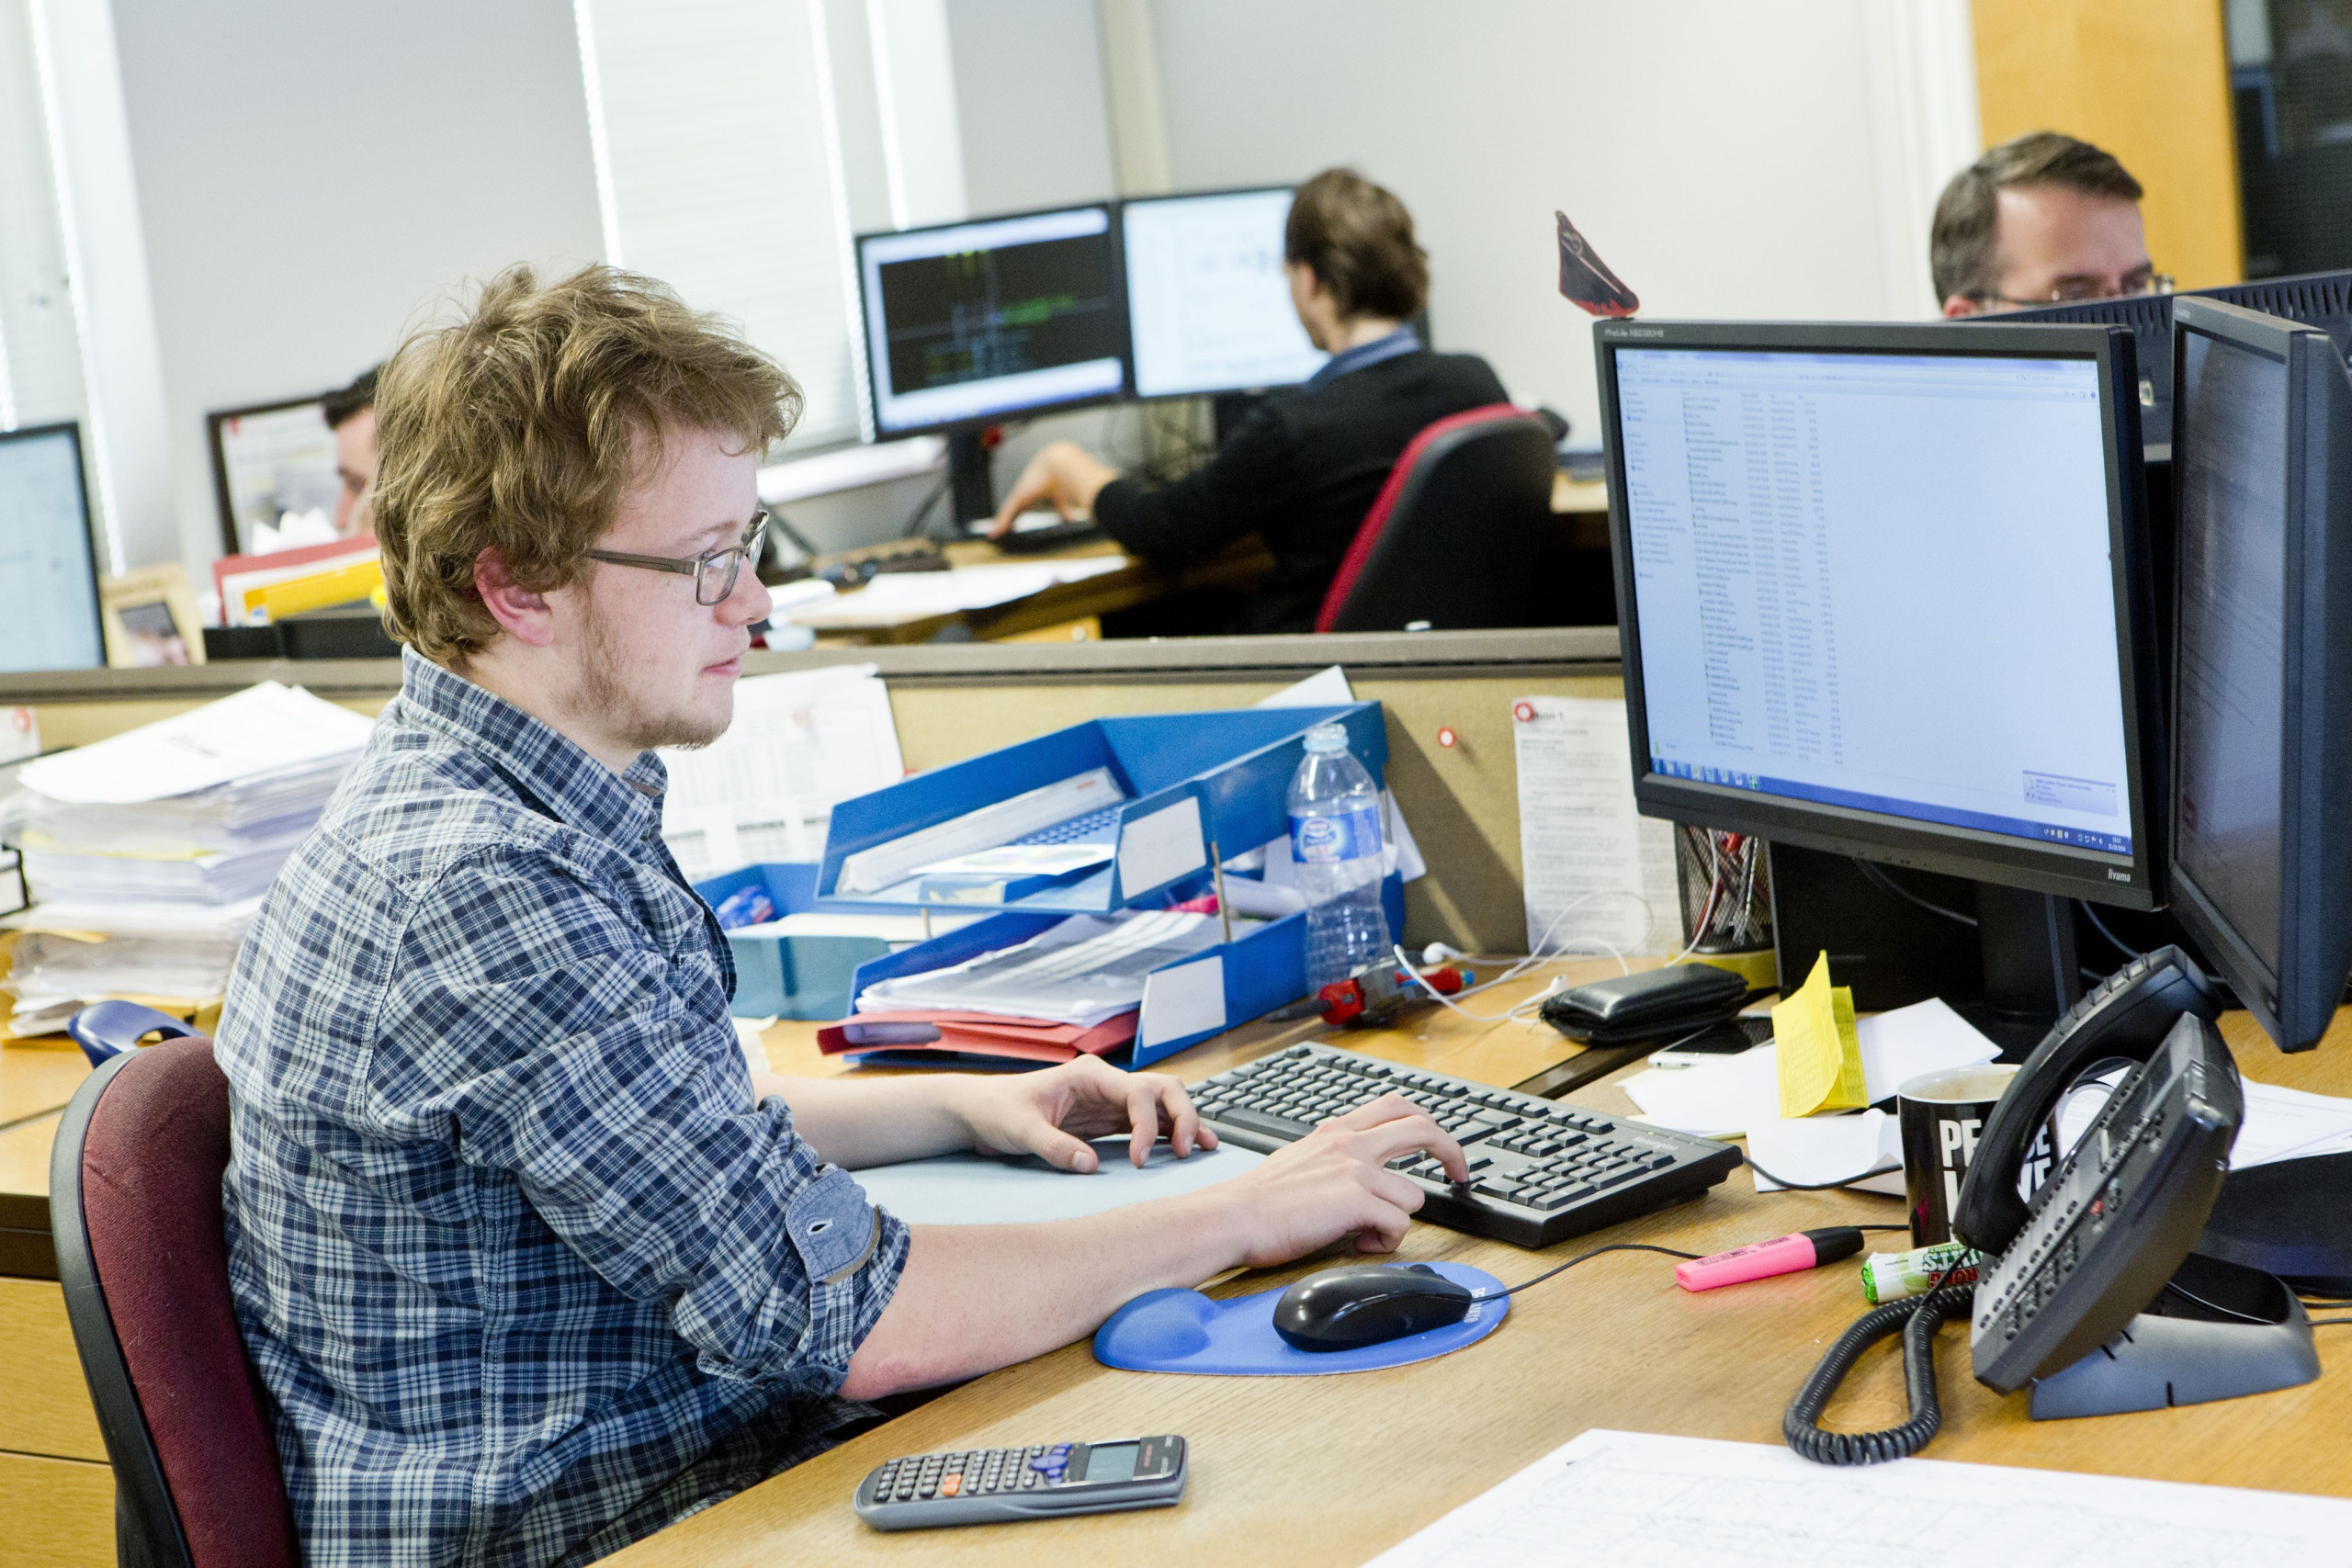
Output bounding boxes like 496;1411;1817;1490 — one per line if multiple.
400;649;671;841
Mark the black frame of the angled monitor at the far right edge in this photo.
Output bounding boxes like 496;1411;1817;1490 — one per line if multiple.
2168;301;2352;1051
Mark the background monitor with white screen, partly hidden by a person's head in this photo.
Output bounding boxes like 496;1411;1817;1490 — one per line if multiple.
1120;186;1329;398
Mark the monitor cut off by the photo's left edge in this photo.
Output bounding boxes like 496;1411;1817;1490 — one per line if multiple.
0;425;106;670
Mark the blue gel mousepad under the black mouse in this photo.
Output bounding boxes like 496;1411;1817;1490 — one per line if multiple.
1093;1262;1510;1378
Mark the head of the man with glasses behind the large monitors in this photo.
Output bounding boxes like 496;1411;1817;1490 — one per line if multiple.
1928;131;2173;315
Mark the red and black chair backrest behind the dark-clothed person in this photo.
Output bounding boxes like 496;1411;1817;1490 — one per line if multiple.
1315;402;1557;632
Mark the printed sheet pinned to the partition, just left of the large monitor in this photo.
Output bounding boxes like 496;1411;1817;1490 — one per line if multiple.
1510;696;1681;957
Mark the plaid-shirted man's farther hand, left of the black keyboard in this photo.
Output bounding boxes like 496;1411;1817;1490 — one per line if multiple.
957;1055;1216;1173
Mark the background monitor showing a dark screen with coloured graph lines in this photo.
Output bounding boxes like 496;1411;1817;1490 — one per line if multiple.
856;202;1131;437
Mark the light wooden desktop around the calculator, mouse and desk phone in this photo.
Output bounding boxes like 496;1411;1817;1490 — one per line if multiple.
612;1013;2352;1568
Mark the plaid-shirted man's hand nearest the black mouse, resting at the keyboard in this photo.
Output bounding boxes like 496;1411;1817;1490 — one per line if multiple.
1211;1093;1470;1269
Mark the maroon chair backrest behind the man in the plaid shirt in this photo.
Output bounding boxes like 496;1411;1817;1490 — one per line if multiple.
50;1037;301;1568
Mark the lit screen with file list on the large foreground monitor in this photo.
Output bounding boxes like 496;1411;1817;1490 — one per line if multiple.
1613;345;2135;867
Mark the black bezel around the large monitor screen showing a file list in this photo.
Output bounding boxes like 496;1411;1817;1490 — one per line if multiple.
1592;320;2168;909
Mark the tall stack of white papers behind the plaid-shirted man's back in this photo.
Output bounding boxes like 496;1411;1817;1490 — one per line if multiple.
5;682;371;1032
